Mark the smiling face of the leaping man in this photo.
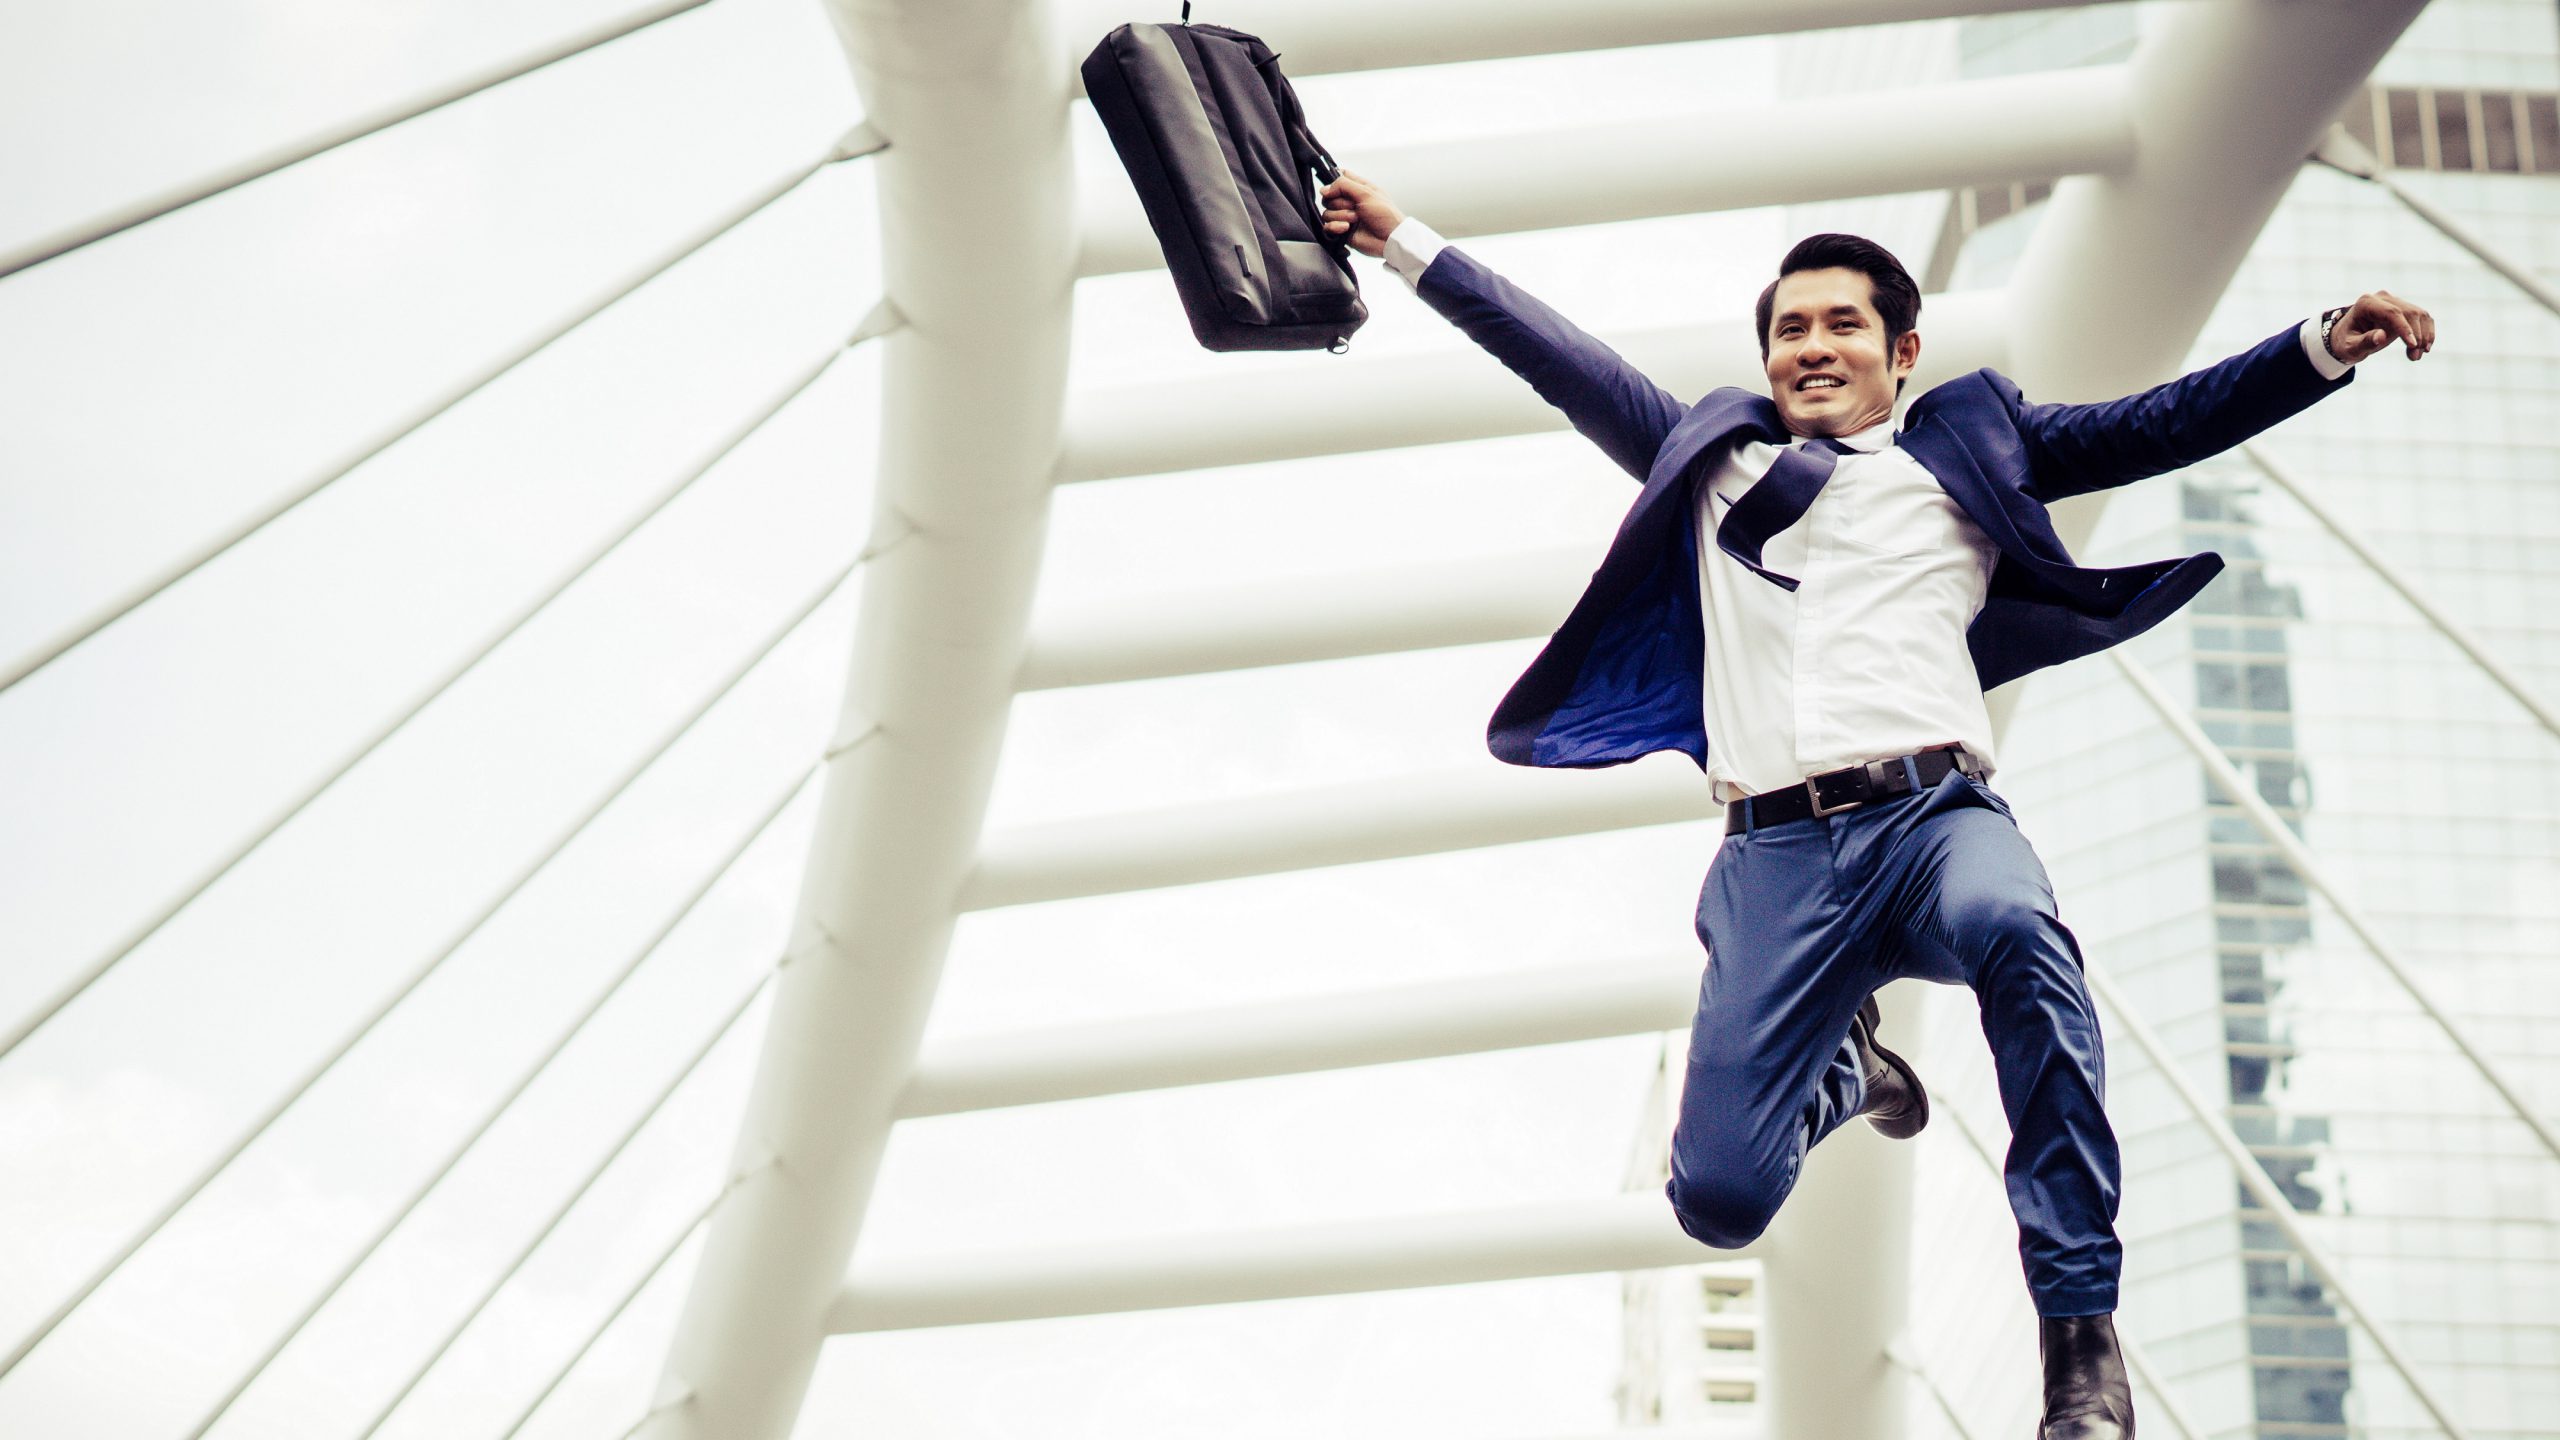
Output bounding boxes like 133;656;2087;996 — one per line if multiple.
1769;266;1920;436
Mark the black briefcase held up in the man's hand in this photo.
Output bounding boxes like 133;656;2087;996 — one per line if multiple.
1083;26;1370;351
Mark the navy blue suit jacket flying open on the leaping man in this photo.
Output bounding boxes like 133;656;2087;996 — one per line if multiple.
1418;246;2355;766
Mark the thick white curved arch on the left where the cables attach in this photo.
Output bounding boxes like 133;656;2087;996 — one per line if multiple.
640;0;1075;1440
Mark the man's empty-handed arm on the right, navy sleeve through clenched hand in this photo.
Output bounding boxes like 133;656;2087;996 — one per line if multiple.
2017;290;2435;502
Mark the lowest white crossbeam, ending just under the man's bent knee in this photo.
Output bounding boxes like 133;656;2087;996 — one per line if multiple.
827;1194;1774;1335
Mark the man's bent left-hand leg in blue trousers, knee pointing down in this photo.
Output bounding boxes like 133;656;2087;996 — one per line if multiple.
1669;825;1884;1250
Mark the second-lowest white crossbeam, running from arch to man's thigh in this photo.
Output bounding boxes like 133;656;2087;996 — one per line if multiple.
899;953;1700;1120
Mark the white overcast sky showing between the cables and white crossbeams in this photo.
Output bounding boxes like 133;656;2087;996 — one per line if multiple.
0;0;1843;1440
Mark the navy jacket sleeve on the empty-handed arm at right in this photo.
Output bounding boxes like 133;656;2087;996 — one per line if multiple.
2002;325;2355;505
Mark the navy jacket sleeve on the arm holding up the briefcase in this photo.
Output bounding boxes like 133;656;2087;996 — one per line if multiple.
1413;246;1687;479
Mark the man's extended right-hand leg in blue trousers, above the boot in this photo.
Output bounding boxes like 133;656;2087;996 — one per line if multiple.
1887;781;2125;1317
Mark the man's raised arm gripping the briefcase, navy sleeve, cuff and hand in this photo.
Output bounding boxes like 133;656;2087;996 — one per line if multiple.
1324;172;1687;479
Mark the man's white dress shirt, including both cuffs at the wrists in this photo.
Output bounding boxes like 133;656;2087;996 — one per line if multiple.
1385;218;2348;802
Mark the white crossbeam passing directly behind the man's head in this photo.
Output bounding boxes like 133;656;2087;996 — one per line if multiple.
1057;292;2007;482
